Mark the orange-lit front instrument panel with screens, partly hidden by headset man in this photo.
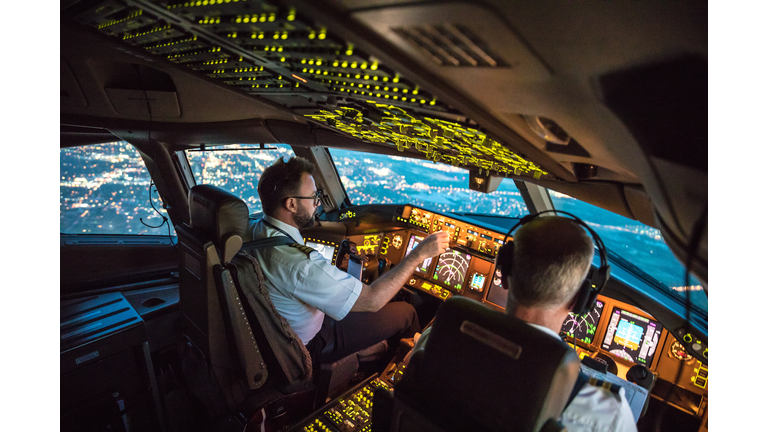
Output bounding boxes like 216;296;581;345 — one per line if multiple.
314;205;708;412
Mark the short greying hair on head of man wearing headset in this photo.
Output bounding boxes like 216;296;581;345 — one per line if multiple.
510;216;594;308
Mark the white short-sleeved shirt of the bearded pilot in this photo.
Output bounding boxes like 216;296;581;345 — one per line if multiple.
253;215;363;345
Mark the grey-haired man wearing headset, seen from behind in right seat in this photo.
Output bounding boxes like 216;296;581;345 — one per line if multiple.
408;216;637;432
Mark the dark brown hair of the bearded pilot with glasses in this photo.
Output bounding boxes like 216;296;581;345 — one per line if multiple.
257;156;315;216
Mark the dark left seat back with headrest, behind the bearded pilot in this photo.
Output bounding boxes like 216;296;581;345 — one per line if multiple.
176;185;268;409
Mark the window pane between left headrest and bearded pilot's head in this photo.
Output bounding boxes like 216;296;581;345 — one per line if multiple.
185;144;294;213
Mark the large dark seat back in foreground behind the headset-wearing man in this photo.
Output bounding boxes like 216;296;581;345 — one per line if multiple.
384;297;579;432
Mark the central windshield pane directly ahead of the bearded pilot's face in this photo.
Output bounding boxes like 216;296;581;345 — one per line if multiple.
329;149;528;217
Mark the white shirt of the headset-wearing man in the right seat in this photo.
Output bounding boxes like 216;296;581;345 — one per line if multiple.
413;323;637;432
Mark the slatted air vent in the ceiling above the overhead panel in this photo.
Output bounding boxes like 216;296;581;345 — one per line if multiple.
392;24;506;67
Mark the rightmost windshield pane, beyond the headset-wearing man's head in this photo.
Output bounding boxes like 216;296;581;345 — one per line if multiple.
549;191;709;314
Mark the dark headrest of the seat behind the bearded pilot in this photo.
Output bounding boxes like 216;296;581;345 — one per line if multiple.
189;185;251;250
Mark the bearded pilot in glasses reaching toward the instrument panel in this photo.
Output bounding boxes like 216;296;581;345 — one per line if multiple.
253;157;448;367
